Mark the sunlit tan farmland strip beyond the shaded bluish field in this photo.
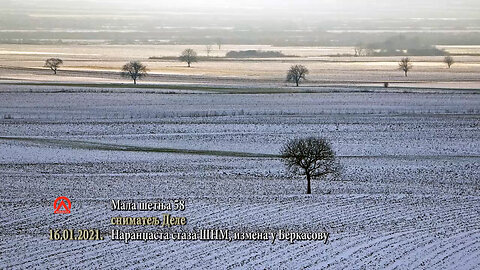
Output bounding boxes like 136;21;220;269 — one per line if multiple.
0;45;480;89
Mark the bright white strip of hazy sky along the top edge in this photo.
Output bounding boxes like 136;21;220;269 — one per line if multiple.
0;0;480;19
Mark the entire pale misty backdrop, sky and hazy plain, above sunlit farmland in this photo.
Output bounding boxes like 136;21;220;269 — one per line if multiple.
0;0;480;45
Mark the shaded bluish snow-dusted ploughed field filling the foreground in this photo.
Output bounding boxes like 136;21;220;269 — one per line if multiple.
0;86;480;269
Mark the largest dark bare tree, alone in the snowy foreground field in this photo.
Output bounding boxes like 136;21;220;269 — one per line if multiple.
281;137;338;194
